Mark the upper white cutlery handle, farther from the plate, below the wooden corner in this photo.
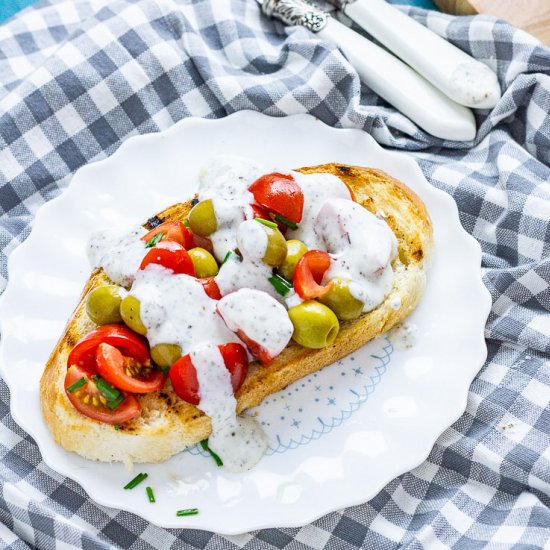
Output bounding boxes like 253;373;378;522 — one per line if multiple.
344;0;501;109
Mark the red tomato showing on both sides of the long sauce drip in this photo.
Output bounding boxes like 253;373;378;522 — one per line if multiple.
170;343;248;405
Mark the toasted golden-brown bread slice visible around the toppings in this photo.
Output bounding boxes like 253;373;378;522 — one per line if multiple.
40;164;432;463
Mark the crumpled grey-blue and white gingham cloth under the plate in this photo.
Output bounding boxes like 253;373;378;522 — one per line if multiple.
0;0;550;549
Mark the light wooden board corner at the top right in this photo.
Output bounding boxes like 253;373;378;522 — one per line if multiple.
434;0;550;45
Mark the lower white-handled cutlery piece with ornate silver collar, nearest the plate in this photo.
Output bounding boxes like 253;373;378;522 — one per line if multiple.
256;0;476;141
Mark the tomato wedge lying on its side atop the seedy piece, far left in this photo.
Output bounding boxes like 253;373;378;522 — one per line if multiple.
96;344;166;393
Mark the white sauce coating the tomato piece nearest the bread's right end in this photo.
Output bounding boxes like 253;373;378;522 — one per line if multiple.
315;199;397;311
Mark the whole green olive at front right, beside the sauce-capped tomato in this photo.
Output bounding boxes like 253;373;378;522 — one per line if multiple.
288;300;340;349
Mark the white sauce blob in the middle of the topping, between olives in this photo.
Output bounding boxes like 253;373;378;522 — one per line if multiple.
215;220;282;301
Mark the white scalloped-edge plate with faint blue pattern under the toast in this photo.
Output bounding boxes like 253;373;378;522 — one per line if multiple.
0;112;490;534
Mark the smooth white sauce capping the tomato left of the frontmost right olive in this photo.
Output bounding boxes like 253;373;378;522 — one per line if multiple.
218;288;294;357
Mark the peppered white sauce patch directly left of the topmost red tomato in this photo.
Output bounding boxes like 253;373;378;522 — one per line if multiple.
199;156;263;261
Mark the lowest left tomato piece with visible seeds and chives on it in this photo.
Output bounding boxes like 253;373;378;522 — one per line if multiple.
65;365;141;424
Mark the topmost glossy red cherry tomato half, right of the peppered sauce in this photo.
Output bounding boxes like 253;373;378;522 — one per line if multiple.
248;172;304;223
